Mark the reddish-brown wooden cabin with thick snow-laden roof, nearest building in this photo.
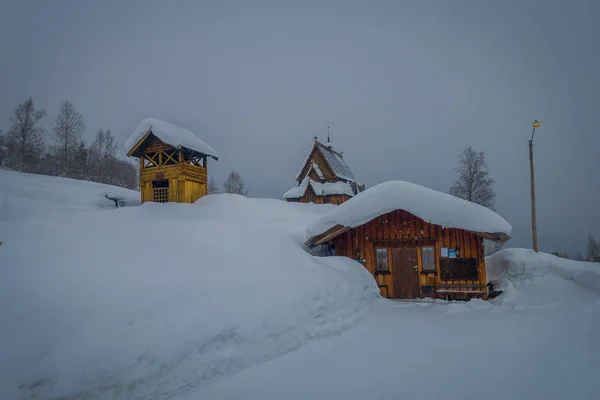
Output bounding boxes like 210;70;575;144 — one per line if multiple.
306;182;511;299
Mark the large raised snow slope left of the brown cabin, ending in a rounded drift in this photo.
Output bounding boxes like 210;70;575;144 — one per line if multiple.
0;172;378;399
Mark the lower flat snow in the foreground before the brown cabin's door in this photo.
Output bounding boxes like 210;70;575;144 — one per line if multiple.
179;277;600;400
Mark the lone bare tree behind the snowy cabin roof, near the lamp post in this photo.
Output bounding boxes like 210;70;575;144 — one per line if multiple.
450;146;496;210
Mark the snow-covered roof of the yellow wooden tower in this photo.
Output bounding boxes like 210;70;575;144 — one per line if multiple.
125;118;219;159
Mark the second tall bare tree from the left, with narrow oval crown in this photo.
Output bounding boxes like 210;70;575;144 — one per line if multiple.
53;101;85;176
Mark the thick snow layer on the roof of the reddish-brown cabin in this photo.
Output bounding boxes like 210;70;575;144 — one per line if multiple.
307;181;512;246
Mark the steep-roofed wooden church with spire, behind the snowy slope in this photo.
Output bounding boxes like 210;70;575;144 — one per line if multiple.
283;136;365;204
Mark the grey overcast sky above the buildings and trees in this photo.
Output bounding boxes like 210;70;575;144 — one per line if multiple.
0;0;600;252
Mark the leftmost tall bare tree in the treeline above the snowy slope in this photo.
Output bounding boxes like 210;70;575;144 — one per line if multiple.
6;97;46;172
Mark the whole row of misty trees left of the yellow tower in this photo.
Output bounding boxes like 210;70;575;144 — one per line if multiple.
0;97;138;189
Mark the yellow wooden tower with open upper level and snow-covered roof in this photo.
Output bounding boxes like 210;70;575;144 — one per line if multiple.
126;119;218;203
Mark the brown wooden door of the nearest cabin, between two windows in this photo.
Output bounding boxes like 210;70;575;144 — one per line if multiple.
392;247;420;299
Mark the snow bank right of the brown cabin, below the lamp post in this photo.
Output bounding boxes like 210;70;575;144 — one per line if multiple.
486;249;600;293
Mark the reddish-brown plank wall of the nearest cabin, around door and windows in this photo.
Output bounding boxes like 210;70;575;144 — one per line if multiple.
331;210;487;297
